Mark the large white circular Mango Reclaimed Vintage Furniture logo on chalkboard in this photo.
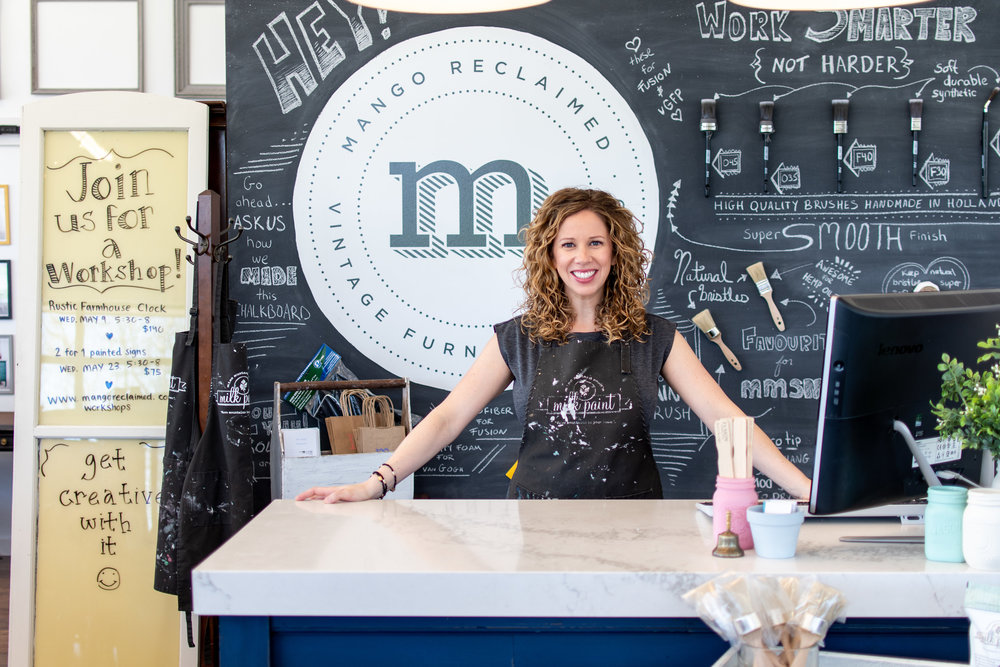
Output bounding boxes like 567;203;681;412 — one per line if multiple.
293;27;659;389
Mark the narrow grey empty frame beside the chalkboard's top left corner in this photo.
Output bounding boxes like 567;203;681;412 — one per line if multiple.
174;0;226;100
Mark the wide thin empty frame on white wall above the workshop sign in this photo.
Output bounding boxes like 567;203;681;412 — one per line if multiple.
31;0;142;93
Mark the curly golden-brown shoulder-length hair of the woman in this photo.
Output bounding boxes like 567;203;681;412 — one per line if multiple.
520;188;652;343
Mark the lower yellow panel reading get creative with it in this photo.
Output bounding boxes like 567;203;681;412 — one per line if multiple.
35;440;180;667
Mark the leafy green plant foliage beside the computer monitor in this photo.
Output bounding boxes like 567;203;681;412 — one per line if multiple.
931;325;1000;483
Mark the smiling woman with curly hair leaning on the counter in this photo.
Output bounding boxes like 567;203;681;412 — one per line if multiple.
296;188;809;503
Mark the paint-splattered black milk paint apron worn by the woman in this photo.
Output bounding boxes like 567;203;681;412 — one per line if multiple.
507;339;663;498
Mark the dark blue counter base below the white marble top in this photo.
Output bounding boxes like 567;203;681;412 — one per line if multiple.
219;616;969;667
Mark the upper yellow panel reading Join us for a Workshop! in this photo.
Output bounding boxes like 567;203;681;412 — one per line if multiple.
38;131;193;426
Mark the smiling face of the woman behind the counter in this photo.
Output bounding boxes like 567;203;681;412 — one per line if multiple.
550;210;615;316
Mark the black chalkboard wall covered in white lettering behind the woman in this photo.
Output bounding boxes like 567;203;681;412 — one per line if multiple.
226;0;1000;505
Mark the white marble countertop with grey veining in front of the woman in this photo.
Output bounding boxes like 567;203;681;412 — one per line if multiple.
193;500;988;618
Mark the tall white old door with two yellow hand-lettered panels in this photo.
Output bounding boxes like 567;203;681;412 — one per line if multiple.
9;92;208;665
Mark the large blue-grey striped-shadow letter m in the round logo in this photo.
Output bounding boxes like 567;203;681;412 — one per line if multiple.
389;160;548;257
